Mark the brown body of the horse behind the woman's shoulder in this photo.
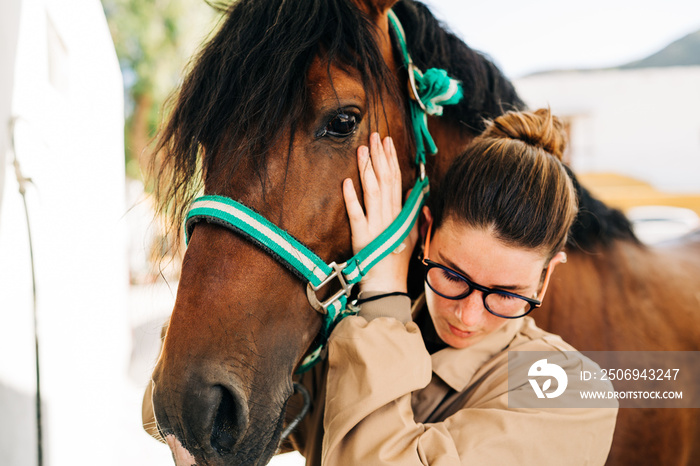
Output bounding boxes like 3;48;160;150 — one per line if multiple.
534;231;700;465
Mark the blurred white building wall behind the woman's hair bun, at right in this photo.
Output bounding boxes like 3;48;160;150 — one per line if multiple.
515;66;700;192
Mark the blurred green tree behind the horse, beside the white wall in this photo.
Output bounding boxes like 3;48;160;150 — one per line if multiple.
102;0;217;179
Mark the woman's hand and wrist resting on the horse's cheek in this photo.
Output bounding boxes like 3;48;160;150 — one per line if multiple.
343;133;418;292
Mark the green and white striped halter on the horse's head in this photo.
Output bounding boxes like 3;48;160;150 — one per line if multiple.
185;10;463;373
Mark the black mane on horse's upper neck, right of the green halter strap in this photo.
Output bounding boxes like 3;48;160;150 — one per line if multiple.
393;0;525;135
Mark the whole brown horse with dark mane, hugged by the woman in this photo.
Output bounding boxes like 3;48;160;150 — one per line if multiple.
150;0;700;465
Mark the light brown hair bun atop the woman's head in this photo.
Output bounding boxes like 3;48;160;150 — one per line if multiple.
482;108;566;160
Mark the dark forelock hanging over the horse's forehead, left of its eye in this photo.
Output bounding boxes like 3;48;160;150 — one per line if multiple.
151;0;398;237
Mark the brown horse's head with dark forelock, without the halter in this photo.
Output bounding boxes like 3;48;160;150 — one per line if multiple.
152;0;521;465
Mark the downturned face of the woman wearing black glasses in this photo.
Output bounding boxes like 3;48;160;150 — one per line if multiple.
425;219;546;348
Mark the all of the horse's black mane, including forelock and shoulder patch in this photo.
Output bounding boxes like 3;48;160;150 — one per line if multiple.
152;0;634;249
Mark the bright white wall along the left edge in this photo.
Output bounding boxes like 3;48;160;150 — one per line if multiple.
0;0;161;466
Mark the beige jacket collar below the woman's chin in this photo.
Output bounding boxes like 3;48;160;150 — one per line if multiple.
412;295;528;392
